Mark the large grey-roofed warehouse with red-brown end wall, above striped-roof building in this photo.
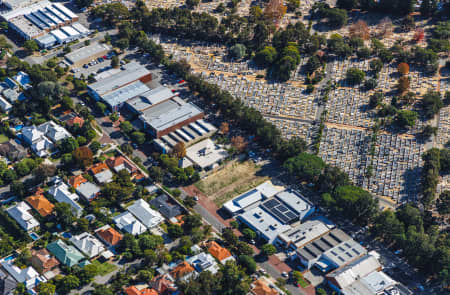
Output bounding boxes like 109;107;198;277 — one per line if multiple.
139;97;204;138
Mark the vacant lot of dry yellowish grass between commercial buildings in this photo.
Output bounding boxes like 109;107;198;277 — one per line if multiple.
195;161;269;207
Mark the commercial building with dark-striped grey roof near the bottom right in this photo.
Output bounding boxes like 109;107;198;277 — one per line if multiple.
296;229;367;273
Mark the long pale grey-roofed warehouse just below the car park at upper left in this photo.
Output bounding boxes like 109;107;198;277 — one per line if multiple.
88;62;152;100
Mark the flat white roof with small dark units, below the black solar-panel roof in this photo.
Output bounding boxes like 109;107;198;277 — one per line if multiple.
238;206;290;243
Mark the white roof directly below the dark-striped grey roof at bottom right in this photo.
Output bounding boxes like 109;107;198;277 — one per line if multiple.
327;255;381;289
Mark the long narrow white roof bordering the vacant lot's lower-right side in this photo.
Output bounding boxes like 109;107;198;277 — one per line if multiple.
223;181;279;213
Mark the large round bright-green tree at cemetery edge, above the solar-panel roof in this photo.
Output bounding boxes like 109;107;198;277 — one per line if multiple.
284;152;325;182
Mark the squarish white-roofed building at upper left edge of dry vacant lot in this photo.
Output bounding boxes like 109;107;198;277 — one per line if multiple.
186;138;228;169
